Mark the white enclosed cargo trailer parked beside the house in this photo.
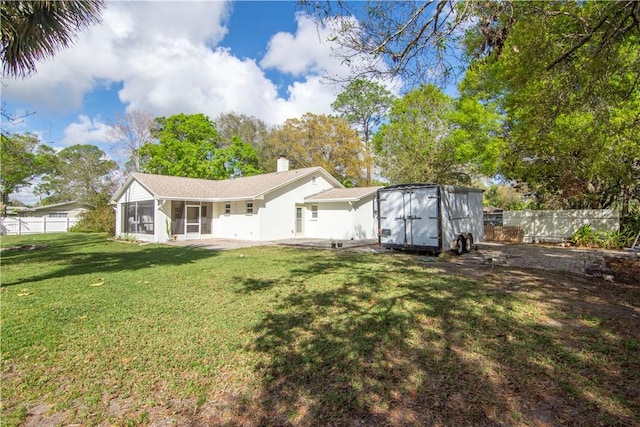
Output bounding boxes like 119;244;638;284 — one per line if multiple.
378;184;484;254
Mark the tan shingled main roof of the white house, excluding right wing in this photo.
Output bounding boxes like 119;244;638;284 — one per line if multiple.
111;166;342;203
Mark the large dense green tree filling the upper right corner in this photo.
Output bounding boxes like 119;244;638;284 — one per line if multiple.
460;2;640;211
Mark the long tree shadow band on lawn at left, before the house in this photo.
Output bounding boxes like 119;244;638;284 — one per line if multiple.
1;234;218;287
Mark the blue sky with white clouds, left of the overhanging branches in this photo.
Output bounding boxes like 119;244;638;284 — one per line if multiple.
2;0;388;203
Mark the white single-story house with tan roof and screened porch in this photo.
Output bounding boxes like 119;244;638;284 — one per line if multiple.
110;159;377;242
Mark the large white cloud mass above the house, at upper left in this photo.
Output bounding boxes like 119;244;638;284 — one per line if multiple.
3;1;364;134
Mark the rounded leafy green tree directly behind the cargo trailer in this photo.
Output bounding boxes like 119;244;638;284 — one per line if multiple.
373;85;502;184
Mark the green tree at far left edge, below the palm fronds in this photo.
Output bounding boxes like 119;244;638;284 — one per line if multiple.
0;133;54;206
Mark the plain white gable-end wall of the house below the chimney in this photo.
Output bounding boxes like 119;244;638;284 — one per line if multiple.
258;174;335;240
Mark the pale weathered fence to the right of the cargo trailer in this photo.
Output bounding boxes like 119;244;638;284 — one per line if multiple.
502;209;620;243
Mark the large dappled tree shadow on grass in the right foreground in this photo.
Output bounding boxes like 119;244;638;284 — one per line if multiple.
228;255;640;425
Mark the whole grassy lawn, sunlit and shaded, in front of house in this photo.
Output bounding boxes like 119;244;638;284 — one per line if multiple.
1;233;640;425
